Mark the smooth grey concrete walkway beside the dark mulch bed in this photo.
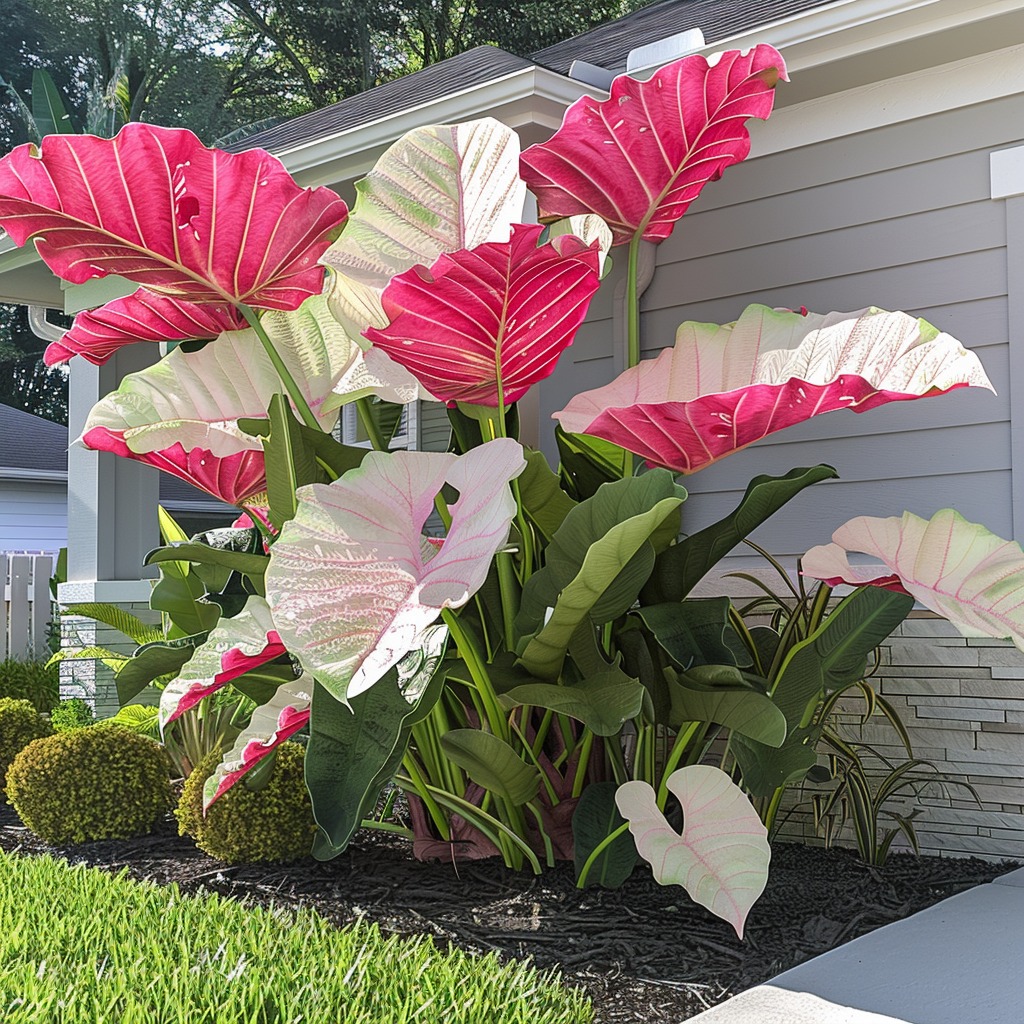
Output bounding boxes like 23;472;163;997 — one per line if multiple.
692;867;1024;1024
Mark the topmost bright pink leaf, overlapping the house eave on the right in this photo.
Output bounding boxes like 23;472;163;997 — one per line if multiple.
519;43;786;245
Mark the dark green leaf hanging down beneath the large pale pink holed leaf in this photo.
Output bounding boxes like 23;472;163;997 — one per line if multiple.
305;626;447;860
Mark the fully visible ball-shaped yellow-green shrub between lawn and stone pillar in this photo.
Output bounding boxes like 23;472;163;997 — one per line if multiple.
7;726;173;845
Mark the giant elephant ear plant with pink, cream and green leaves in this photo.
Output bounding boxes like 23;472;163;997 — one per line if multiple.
0;45;1024;934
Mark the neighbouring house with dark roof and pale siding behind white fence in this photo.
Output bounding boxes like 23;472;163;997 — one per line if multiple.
0;404;238;554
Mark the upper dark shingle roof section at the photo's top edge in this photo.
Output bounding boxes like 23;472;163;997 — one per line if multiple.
532;0;835;75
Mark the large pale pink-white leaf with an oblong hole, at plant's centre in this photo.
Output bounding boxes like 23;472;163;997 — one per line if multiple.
266;438;526;700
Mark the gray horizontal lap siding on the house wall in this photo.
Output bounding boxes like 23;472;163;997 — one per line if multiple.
542;96;1024;557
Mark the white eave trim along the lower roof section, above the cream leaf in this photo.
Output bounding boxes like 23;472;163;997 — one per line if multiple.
274;67;606;186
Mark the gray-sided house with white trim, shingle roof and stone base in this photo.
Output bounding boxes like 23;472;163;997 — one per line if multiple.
0;0;1024;857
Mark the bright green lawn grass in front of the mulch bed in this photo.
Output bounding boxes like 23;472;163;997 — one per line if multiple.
0;851;592;1024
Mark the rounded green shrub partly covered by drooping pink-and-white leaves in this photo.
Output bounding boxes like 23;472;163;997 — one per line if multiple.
174;743;316;864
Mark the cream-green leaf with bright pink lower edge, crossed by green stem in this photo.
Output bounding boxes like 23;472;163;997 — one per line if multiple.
82;296;418;505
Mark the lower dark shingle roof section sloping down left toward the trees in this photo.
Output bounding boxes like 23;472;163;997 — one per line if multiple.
227;46;534;153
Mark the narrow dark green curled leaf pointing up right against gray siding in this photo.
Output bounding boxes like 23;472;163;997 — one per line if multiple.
643;465;839;604
